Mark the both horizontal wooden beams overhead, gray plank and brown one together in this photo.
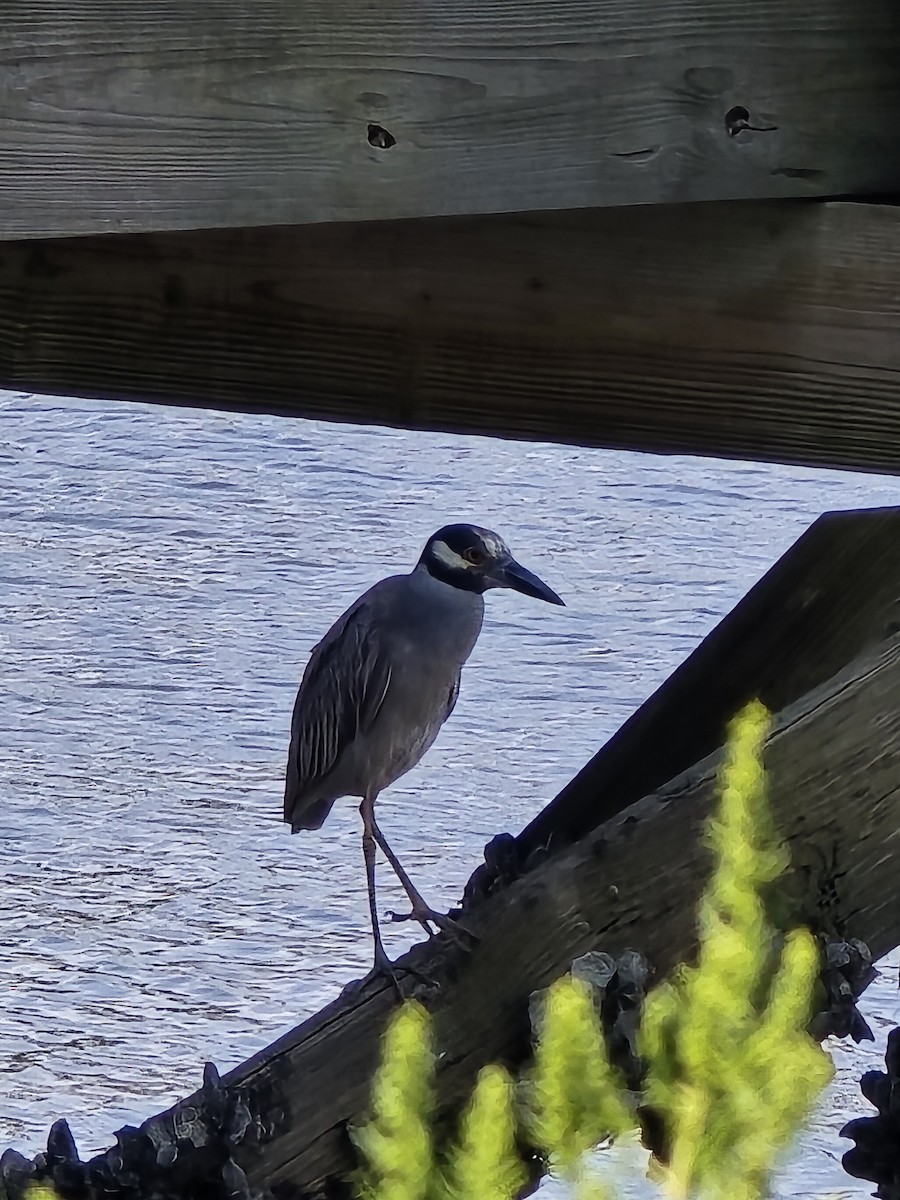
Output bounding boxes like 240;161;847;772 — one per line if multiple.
0;0;900;472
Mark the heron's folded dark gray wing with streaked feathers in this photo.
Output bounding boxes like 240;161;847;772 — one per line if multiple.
284;602;391;821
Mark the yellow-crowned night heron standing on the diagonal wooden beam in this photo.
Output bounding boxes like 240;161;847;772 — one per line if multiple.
284;524;564;978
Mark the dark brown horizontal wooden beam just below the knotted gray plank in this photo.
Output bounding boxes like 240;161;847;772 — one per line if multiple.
0;204;900;472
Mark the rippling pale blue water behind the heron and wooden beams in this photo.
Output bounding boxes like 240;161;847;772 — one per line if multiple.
0;394;900;1195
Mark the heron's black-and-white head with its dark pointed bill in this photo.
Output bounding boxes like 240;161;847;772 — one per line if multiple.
419;524;565;604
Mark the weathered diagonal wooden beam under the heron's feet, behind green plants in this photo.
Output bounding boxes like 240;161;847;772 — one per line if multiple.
65;635;900;1195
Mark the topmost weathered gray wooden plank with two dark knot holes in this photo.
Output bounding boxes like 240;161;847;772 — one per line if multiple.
0;0;900;238
